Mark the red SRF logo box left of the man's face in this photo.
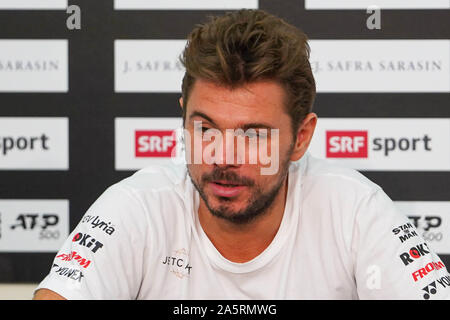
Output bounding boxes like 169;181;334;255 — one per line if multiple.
135;130;176;158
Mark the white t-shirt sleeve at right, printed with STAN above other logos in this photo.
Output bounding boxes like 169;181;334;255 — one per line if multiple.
352;189;450;300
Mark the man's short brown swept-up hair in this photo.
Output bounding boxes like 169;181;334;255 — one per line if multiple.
180;9;316;133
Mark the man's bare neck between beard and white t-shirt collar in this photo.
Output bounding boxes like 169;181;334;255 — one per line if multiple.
198;178;288;263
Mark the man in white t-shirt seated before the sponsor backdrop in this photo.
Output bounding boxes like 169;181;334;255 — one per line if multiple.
35;10;450;299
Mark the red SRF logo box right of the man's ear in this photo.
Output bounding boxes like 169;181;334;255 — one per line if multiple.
326;131;368;158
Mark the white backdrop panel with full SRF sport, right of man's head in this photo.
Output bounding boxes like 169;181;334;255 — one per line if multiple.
309;118;450;171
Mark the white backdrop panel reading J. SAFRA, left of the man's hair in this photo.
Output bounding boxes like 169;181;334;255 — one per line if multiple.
114;40;186;92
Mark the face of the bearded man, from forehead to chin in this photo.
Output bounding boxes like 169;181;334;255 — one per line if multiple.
181;80;295;223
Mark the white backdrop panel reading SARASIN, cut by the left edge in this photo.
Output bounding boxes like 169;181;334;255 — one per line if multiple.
0;40;69;92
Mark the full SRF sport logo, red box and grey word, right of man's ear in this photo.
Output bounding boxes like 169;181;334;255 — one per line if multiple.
326;130;431;158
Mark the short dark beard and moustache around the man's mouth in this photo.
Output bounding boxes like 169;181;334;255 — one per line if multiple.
187;151;290;225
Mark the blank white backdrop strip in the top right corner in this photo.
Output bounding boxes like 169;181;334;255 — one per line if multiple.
305;0;450;9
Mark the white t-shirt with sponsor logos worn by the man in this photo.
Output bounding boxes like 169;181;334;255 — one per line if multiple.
37;155;450;299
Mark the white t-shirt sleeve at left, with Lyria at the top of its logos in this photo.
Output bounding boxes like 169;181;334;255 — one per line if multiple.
36;184;148;300
